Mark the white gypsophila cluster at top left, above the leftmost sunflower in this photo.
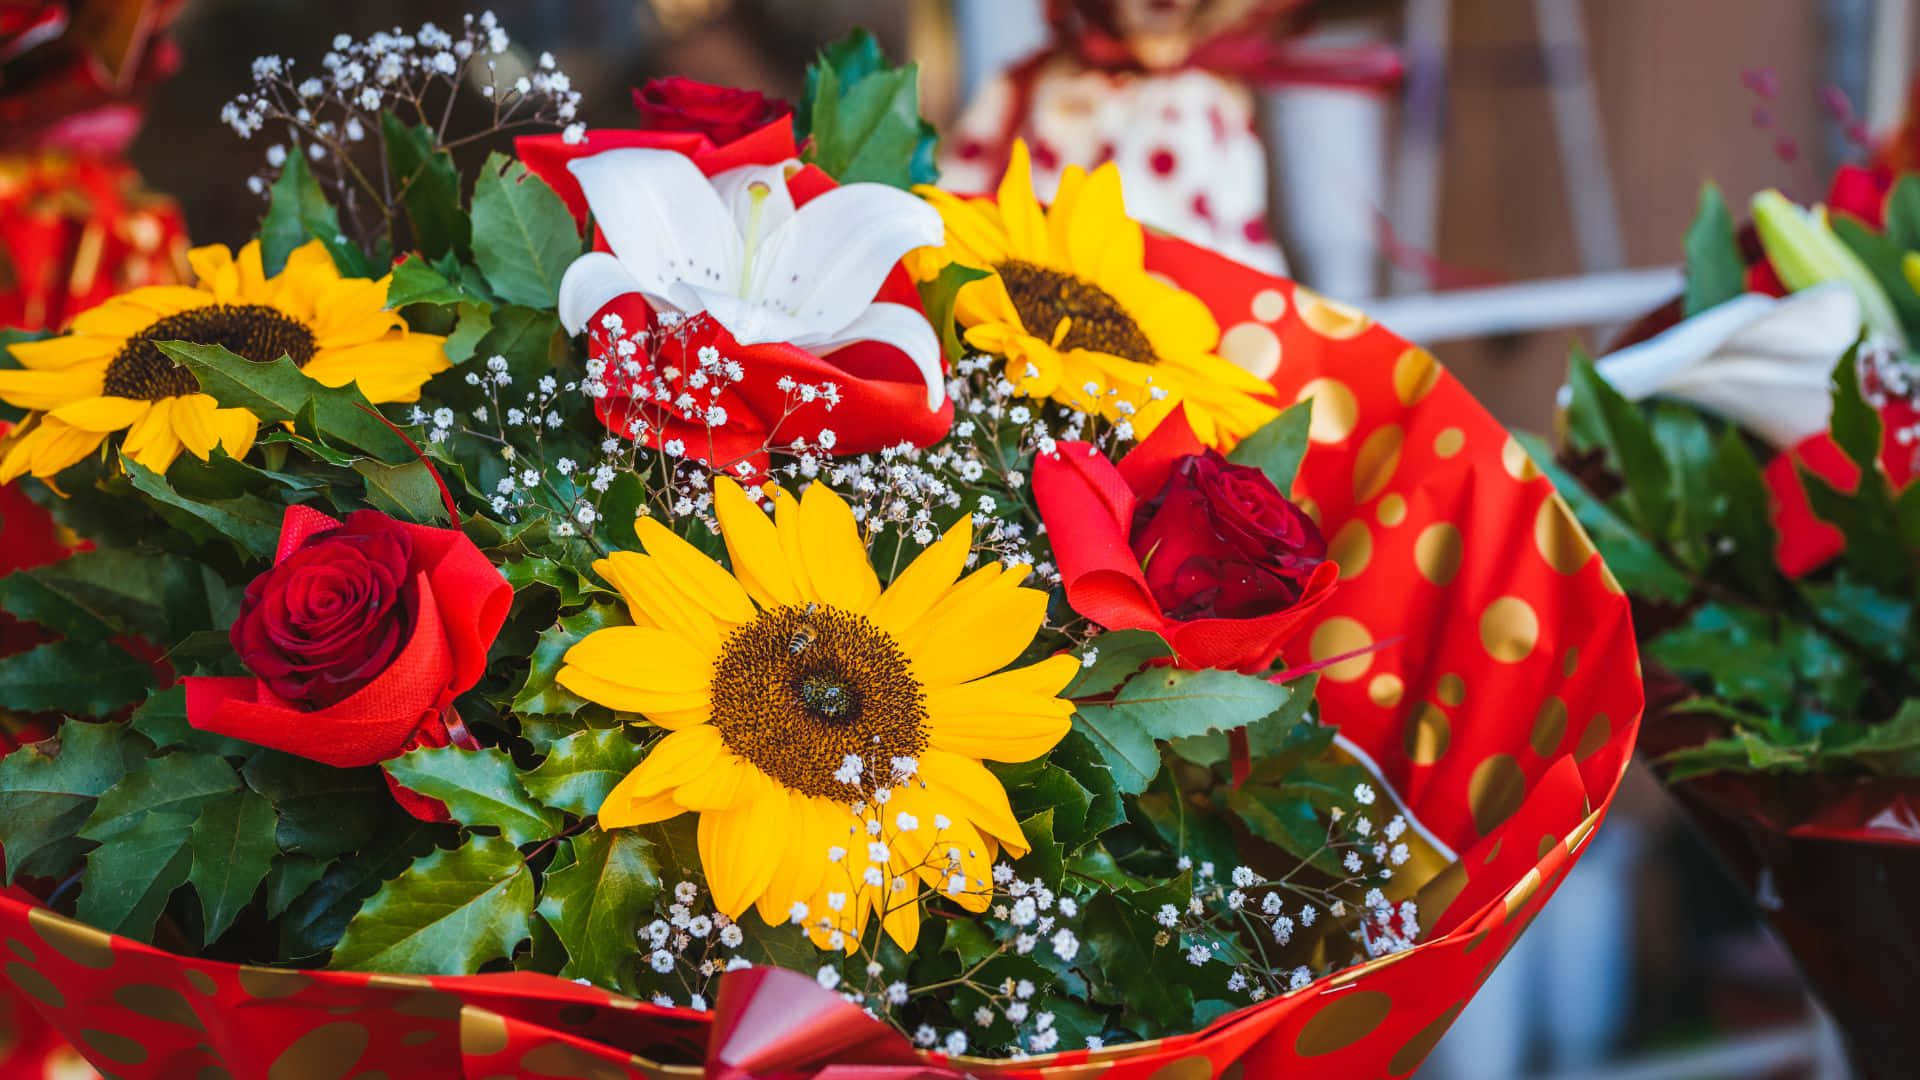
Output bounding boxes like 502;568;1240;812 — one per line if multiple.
221;12;586;226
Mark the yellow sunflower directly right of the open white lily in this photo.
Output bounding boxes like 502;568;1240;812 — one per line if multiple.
906;140;1279;450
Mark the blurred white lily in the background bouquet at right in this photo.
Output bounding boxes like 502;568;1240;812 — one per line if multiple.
1561;281;1862;450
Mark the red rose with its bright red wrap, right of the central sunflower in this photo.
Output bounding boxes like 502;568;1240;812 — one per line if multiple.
1033;409;1340;673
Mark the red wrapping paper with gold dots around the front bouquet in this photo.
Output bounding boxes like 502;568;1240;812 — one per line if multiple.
0;226;1642;1080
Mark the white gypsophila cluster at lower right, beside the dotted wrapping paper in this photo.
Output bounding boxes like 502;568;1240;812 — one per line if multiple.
1154;782;1421;1001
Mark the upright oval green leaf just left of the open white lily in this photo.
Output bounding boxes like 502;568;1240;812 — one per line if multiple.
472;152;580;307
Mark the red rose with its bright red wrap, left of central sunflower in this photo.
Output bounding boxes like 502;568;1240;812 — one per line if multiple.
186;505;513;769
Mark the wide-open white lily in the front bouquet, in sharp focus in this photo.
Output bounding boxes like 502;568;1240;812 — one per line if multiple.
559;148;945;409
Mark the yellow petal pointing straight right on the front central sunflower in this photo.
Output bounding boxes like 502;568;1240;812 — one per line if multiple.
927;655;1079;761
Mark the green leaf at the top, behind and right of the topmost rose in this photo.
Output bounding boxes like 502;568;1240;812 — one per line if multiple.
799;31;939;188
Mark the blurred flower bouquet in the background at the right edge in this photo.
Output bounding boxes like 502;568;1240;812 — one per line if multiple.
1555;90;1920;1076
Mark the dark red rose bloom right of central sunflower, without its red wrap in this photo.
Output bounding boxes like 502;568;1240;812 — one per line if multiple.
1133;450;1327;619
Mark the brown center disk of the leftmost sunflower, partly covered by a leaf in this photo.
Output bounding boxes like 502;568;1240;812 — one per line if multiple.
106;304;319;402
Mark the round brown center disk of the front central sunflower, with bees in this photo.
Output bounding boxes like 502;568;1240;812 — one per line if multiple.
712;605;927;803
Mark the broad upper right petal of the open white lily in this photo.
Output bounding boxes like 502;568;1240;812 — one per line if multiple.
744;183;947;344
